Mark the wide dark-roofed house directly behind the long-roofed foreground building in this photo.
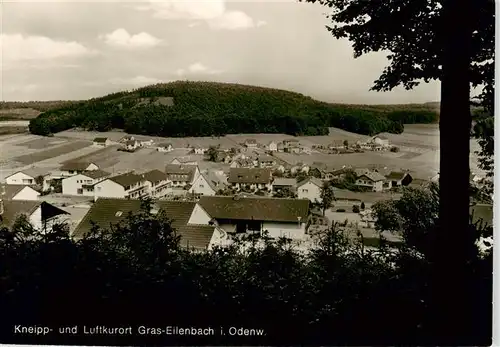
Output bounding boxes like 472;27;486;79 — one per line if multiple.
228;168;273;191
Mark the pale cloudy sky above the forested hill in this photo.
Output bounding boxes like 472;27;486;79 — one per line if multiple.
0;0;439;104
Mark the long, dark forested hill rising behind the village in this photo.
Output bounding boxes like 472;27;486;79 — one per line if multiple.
30;81;438;137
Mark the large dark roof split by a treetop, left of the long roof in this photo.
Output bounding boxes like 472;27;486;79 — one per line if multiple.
73;198;214;249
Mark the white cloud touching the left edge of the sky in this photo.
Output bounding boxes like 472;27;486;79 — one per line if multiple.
0;34;96;64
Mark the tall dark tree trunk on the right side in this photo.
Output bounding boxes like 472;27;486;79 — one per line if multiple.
431;0;474;345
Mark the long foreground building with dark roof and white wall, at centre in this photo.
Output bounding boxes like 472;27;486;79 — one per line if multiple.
197;196;310;240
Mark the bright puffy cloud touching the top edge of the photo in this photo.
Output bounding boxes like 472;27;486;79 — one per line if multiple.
135;0;264;30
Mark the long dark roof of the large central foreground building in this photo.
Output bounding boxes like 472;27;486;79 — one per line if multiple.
198;196;309;223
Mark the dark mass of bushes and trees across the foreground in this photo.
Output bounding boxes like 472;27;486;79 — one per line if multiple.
0;191;492;345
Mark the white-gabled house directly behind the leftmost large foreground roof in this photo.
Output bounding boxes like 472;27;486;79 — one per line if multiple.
94;172;148;200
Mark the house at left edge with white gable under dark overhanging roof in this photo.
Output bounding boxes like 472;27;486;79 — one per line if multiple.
0;199;69;231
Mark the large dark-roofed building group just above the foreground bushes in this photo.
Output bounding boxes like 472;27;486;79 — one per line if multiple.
73;196;310;250
